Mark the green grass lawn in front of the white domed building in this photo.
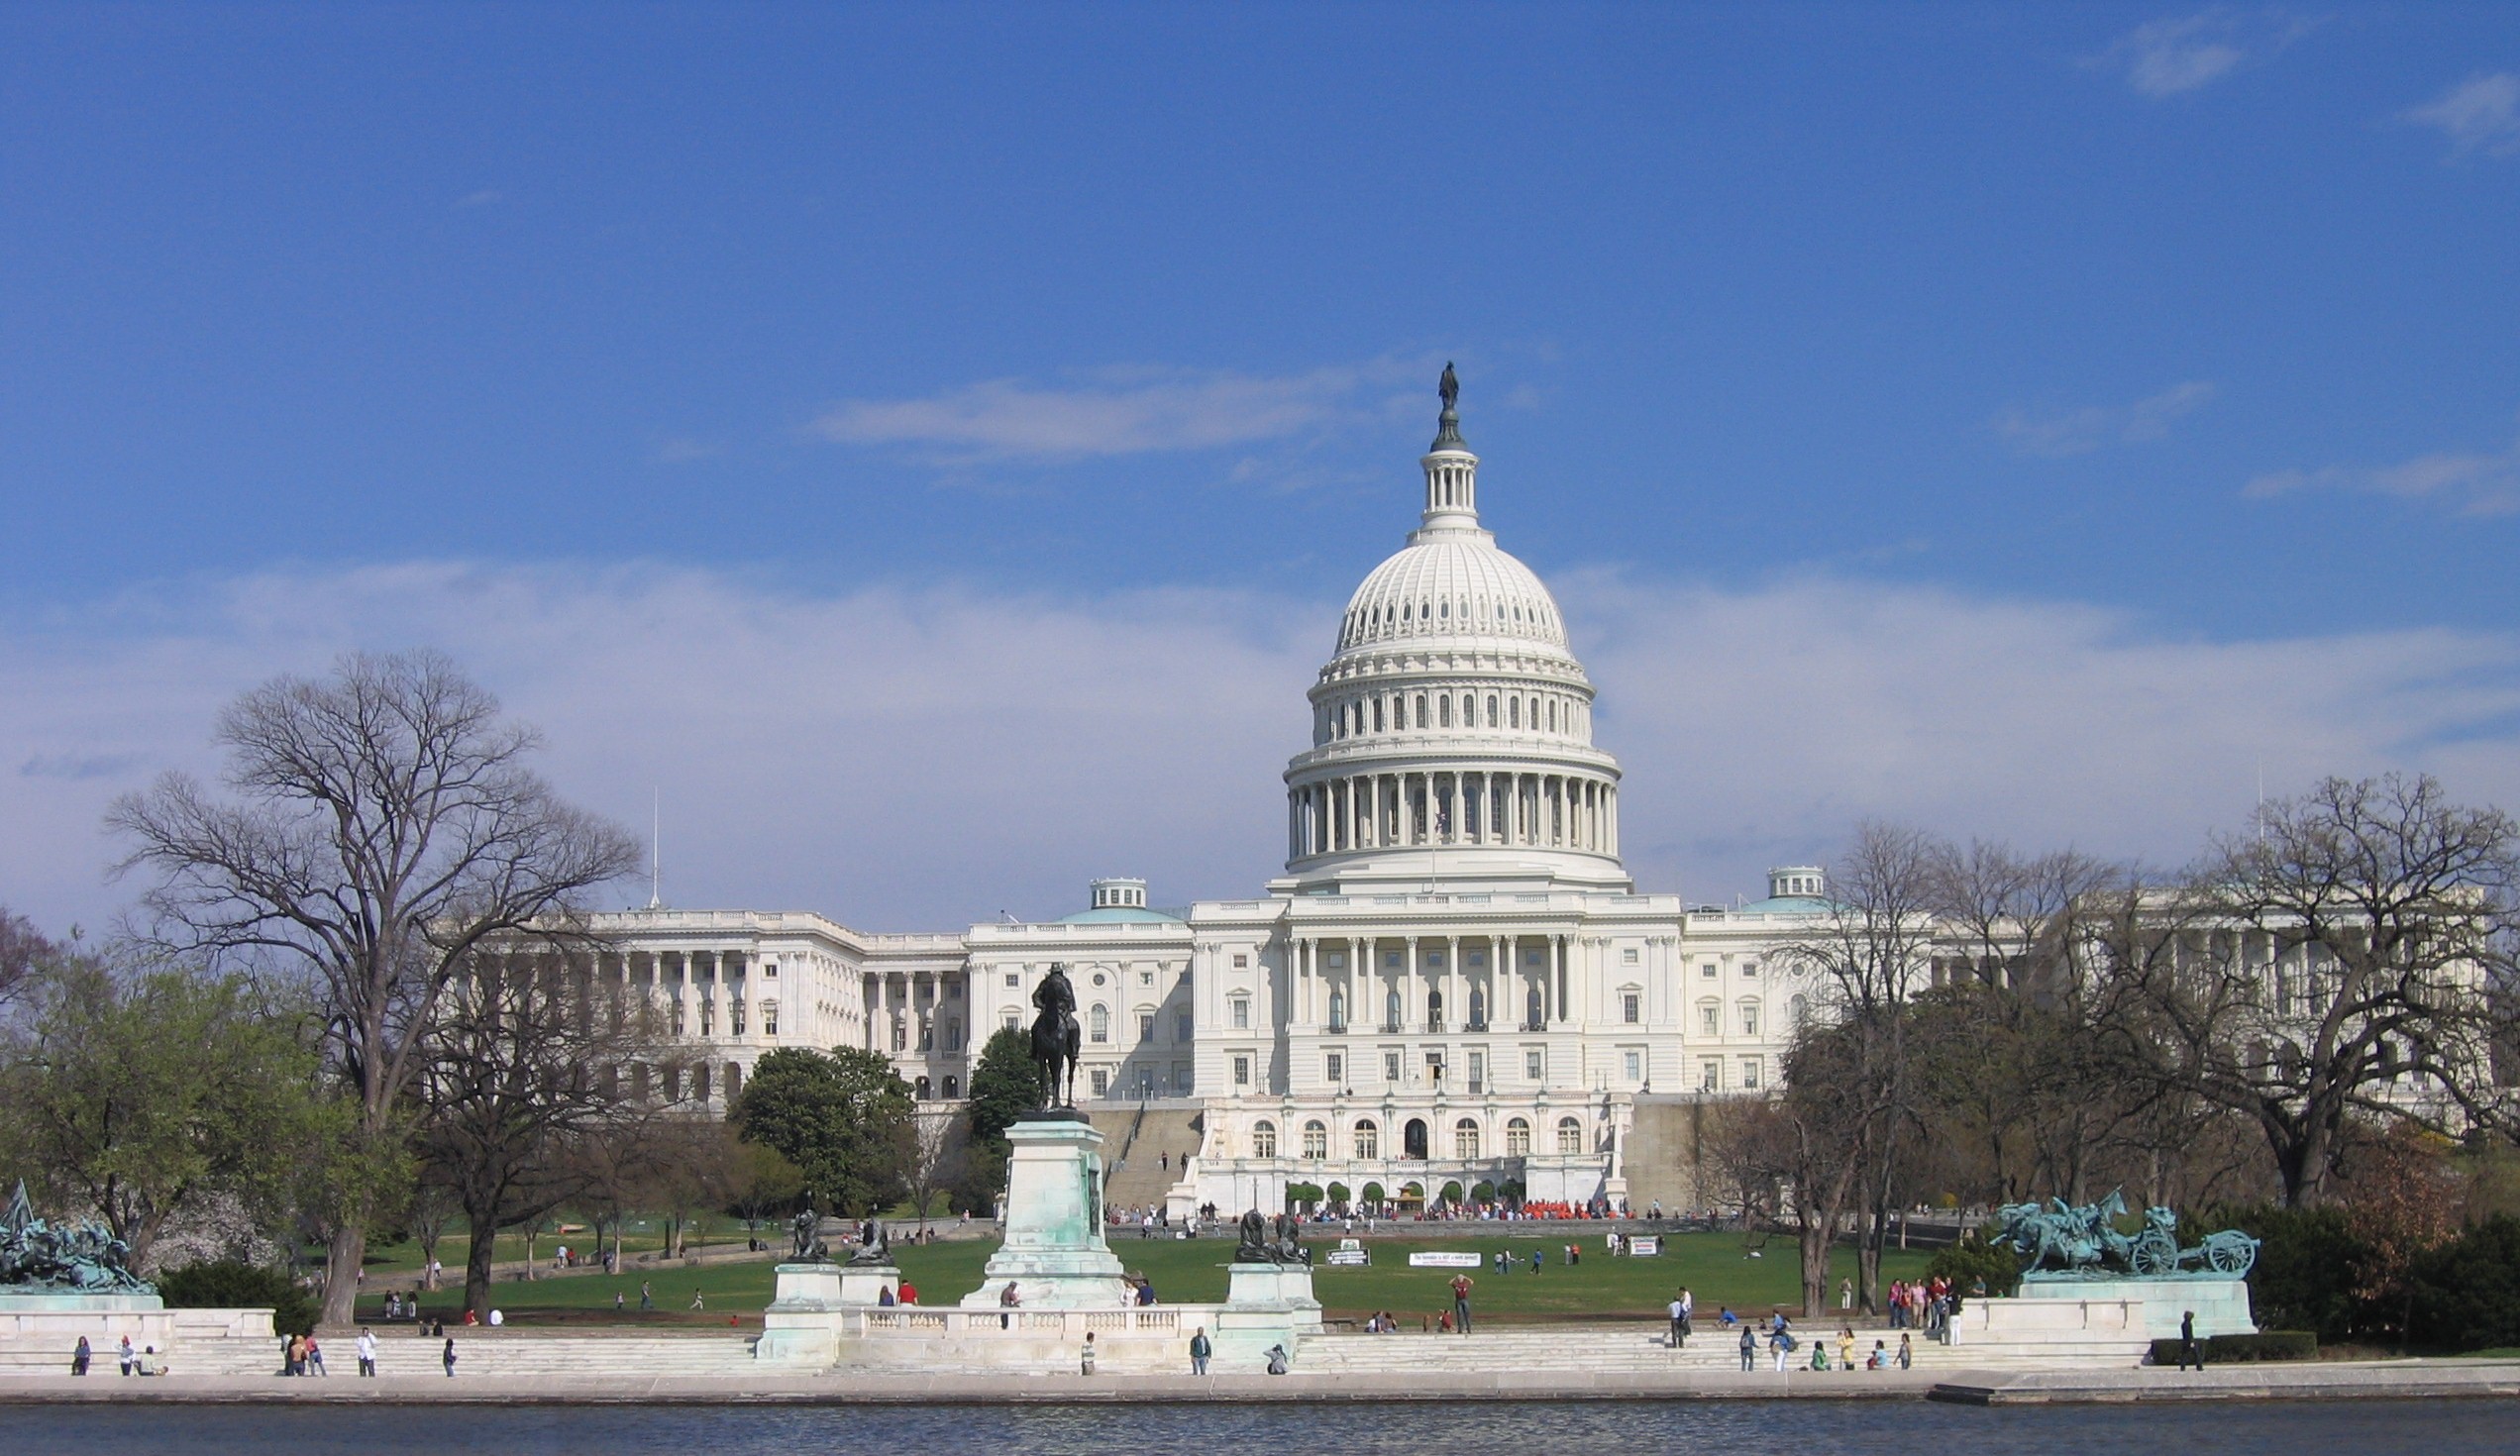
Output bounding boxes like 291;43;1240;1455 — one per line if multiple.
361;1229;1928;1325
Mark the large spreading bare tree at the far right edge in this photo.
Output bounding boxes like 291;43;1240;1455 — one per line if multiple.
2097;776;2520;1206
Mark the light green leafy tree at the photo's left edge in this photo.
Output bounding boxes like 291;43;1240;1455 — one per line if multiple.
0;957;320;1265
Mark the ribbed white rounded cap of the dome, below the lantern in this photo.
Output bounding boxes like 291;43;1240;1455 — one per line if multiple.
1338;532;1567;653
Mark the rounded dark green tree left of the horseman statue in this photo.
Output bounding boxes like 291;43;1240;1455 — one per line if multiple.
726;1045;914;1216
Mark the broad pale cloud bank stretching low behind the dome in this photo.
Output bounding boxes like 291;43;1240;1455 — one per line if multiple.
0;554;2520;929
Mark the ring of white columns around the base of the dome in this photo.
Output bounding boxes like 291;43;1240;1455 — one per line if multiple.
1285;771;1618;859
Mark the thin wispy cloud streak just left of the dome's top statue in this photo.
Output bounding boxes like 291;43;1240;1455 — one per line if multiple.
814;358;1434;461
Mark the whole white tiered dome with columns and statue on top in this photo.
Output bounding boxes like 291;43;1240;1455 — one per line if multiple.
1285;365;1630;891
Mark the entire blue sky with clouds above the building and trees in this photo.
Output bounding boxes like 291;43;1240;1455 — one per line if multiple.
0;5;2520;927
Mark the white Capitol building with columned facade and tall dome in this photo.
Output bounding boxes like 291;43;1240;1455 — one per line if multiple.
599;380;1854;1214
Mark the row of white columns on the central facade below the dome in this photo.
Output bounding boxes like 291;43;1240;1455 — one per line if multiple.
1288;935;1572;1033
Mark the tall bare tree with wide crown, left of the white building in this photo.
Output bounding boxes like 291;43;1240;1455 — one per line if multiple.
108;653;638;1322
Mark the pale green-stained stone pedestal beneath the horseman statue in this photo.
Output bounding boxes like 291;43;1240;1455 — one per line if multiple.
963;1121;1131;1309
